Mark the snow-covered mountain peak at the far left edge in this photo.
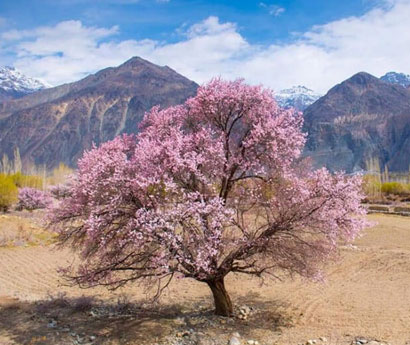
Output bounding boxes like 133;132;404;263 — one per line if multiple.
0;66;50;102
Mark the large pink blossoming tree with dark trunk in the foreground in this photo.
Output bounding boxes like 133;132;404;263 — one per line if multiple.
50;79;366;316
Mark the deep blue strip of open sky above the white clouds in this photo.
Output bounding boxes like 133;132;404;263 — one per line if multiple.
0;0;376;43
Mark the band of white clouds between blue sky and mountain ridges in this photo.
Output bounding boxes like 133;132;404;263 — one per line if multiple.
0;0;410;92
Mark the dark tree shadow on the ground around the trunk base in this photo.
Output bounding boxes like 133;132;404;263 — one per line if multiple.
0;294;292;345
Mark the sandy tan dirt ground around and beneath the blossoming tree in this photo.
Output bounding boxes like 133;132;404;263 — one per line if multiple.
0;215;410;345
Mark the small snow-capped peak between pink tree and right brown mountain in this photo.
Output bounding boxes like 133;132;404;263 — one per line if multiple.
275;85;322;111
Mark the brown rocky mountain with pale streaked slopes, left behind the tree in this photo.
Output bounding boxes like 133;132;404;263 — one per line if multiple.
0;57;198;168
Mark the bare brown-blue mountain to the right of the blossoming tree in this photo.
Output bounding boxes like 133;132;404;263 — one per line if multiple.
304;72;410;172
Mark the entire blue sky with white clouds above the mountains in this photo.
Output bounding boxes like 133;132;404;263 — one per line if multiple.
0;0;410;93
